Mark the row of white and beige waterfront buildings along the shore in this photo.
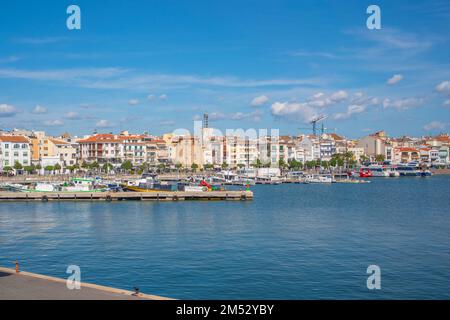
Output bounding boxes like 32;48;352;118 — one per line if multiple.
0;127;450;172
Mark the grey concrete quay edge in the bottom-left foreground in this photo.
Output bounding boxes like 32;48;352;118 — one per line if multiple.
0;267;172;300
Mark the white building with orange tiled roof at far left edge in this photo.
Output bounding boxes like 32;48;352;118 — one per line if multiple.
0;135;31;170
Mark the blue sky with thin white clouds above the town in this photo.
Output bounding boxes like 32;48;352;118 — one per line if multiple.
0;0;450;137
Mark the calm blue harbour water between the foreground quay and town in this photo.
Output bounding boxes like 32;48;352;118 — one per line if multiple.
0;176;450;299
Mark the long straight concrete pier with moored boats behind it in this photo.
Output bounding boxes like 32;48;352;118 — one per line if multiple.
0;191;253;201
